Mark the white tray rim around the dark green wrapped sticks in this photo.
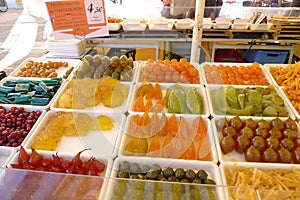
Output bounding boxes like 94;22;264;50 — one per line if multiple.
0;76;65;110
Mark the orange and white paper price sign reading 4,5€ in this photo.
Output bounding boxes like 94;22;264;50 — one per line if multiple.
46;0;109;40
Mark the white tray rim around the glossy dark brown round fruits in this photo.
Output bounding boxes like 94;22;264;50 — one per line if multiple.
212;116;300;163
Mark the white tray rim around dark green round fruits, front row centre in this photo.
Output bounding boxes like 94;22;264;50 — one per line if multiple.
105;157;224;200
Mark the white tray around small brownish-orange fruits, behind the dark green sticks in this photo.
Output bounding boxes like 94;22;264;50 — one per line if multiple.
9;57;80;78
